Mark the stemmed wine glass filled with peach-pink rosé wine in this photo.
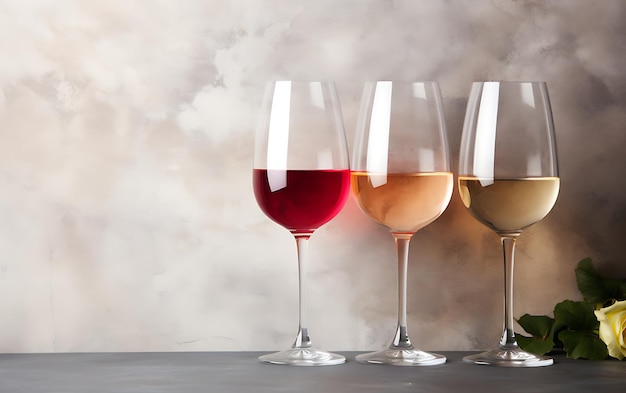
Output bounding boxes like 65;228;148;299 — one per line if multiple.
351;81;453;366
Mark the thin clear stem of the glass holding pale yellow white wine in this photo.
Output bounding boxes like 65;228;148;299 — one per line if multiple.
500;233;519;349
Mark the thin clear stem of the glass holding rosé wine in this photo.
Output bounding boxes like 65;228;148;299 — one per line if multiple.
391;233;413;348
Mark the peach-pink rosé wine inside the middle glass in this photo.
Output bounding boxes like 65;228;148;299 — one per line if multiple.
352;172;453;233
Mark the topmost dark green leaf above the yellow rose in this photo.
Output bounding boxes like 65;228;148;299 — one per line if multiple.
575;258;626;304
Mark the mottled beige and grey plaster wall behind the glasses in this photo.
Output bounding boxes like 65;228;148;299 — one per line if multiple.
0;0;626;352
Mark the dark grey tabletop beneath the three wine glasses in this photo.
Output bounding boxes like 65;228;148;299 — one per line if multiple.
0;351;626;393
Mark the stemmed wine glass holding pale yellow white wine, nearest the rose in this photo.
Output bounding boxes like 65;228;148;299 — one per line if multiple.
458;82;560;367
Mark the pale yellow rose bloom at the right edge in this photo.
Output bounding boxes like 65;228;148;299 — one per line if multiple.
594;300;626;360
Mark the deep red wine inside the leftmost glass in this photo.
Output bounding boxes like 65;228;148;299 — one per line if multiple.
253;169;350;233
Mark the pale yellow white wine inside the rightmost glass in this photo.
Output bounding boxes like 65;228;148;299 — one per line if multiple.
459;176;560;232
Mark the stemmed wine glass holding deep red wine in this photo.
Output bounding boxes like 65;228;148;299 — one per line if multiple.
253;81;350;366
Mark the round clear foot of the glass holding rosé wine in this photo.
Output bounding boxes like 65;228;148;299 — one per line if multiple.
356;347;446;366
